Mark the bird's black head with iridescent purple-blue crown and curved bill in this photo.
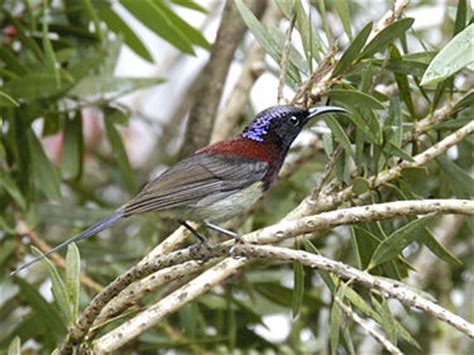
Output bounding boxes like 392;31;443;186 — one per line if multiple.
242;105;347;148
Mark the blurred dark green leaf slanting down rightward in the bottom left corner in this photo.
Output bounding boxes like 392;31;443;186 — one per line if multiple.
15;277;66;342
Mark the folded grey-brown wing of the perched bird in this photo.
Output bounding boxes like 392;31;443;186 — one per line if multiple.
123;153;269;216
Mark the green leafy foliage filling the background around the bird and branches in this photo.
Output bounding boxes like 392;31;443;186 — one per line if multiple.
0;0;474;354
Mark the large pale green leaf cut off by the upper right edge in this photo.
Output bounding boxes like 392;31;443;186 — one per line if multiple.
421;24;474;86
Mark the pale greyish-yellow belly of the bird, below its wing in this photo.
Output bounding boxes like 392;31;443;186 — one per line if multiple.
167;182;263;222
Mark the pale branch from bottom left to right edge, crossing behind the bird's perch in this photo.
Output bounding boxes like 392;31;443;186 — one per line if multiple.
90;200;474;353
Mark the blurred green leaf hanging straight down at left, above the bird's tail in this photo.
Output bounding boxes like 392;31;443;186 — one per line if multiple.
61;112;84;179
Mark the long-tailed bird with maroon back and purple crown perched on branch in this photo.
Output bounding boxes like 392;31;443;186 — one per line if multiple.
12;105;348;274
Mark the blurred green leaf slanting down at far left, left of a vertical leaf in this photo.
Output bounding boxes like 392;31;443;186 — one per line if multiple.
27;129;61;199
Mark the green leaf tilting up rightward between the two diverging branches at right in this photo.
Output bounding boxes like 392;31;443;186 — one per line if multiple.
369;214;435;269
